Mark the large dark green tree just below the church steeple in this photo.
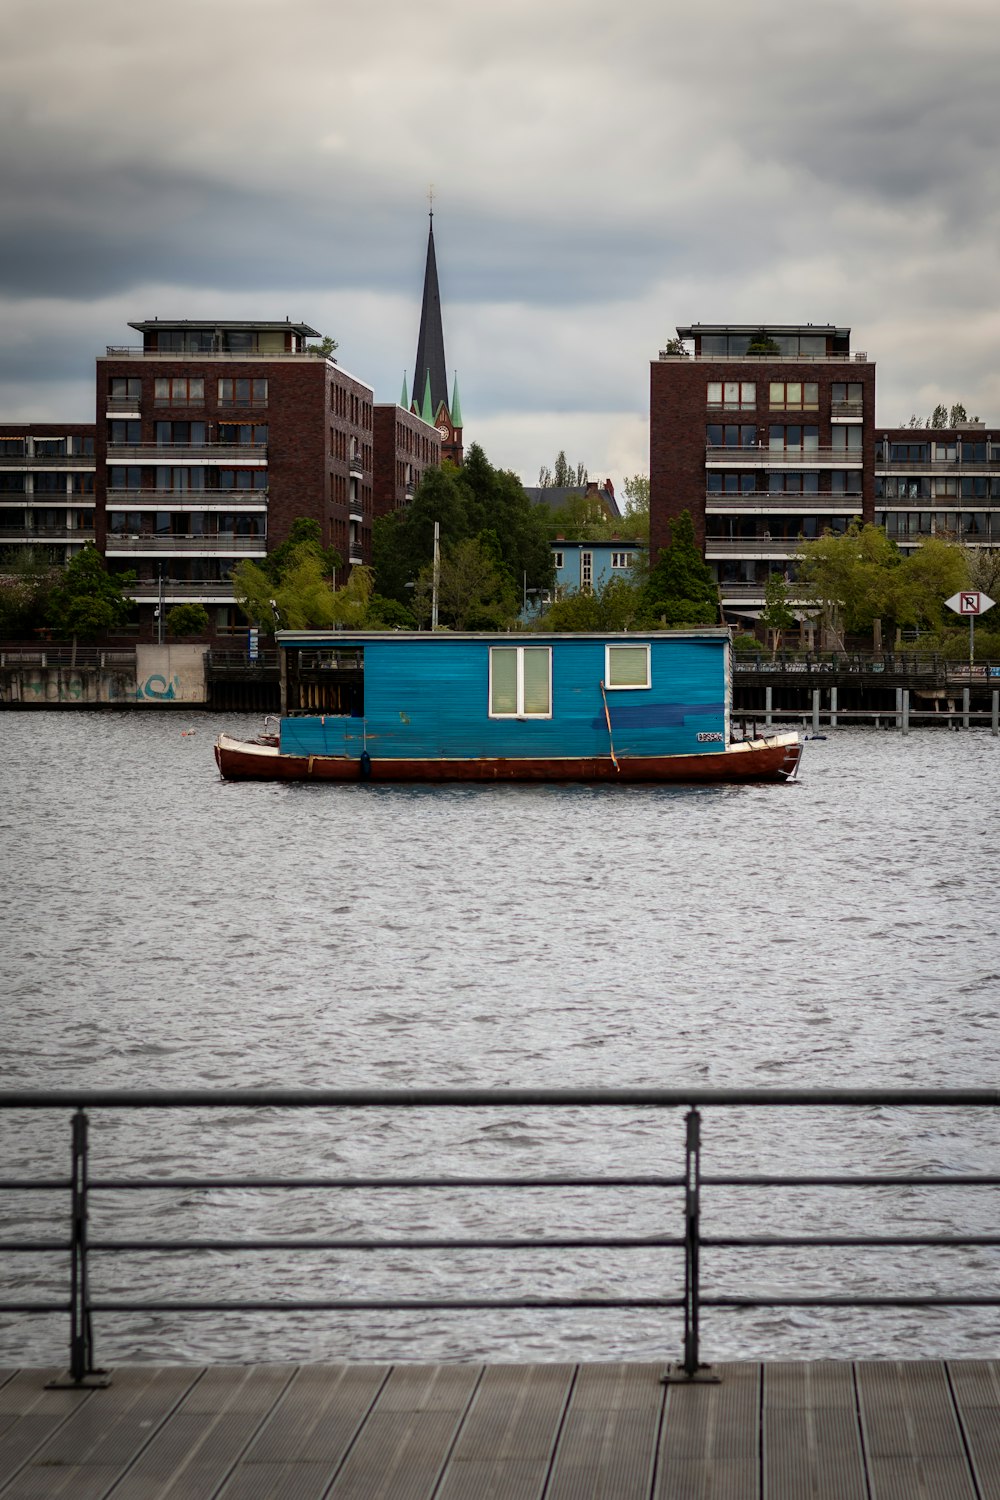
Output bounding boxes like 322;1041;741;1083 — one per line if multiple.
372;443;552;618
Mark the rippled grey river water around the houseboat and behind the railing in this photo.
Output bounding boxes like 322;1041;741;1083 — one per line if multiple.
0;713;1000;1364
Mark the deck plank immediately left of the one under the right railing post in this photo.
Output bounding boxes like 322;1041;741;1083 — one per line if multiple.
546;1364;667;1500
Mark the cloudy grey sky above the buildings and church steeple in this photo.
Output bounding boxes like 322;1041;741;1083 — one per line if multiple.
0;0;1000;483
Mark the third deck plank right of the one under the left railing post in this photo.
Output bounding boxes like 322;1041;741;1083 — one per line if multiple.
220;1365;390;1500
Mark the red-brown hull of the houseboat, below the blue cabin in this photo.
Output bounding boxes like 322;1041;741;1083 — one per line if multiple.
216;735;802;782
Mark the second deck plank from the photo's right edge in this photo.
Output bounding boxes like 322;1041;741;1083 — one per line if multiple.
855;1361;976;1500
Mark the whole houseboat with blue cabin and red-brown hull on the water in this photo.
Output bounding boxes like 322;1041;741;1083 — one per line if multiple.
216;627;802;782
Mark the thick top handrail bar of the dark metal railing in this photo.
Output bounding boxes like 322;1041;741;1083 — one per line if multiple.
0;1089;1000;1110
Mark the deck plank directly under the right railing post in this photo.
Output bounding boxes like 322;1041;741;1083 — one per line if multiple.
655;1364;760;1500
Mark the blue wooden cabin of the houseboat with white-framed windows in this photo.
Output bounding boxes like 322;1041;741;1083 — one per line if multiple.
277;627;732;761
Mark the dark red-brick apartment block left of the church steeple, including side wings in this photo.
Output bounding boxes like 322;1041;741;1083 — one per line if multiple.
0;320;441;638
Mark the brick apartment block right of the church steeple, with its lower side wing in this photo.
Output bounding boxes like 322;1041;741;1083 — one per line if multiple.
649;323;1000;620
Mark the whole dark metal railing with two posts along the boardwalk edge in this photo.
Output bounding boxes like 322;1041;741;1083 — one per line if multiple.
0;1089;1000;1385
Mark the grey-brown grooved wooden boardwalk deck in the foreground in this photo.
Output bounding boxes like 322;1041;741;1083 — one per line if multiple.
0;1361;1000;1500
